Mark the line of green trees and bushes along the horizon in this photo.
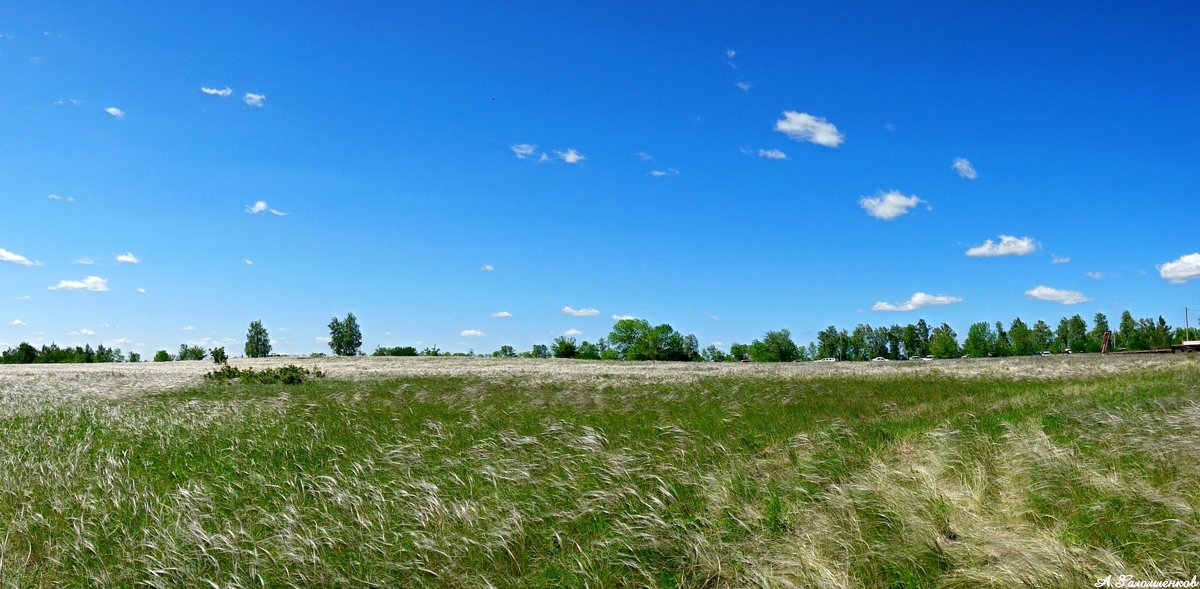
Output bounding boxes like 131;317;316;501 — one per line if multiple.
0;311;1200;363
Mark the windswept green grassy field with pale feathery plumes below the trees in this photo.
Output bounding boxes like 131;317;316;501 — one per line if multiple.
0;355;1200;588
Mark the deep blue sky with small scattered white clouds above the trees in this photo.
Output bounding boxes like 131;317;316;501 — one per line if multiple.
0;1;1200;354
